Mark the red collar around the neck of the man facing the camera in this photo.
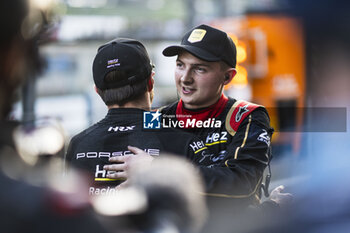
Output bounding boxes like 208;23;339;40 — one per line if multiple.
176;94;228;128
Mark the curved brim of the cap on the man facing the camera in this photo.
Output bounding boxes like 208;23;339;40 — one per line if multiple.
163;45;221;61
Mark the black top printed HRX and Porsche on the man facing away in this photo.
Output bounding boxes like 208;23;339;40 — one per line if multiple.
65;108;204;195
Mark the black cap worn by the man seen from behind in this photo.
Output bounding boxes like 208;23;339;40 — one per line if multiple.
92;38;152;90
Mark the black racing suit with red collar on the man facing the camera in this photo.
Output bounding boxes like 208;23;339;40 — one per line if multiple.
161;95;273;203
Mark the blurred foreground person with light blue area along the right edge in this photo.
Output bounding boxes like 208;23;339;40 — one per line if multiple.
224;0;350;233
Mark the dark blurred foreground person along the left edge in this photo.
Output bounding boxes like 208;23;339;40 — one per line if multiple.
0;0;104;233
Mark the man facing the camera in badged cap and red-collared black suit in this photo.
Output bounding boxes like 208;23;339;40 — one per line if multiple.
105;25;273;208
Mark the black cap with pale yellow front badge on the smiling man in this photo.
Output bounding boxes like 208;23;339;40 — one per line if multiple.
163;24;237;68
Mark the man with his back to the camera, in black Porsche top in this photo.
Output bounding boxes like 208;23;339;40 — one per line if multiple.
65;38;206;195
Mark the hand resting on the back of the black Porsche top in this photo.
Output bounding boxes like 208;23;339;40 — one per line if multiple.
103;146;153;179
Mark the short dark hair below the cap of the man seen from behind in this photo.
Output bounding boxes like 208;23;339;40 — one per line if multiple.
97;70;151;106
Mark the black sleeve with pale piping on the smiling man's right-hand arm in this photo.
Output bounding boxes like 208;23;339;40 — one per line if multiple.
197;111;273;198
